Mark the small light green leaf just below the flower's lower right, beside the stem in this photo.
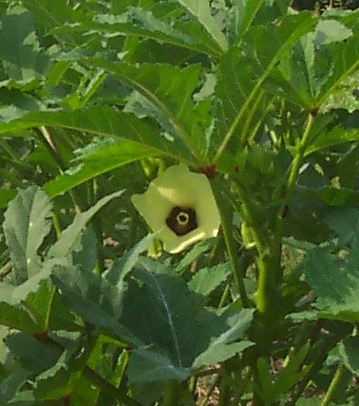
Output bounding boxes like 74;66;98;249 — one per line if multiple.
188;263;231;297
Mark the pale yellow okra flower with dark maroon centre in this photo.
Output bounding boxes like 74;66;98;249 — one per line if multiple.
132;164;220;253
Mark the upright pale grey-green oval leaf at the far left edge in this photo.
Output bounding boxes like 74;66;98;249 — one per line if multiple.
3;186;52;284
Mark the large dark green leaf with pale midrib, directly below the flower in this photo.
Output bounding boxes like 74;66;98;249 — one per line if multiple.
121;258;253;373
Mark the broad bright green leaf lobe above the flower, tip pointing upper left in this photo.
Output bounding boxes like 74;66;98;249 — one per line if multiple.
89;59;211;161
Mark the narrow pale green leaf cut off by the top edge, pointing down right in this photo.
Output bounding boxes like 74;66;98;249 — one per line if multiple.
177;0;228;51
